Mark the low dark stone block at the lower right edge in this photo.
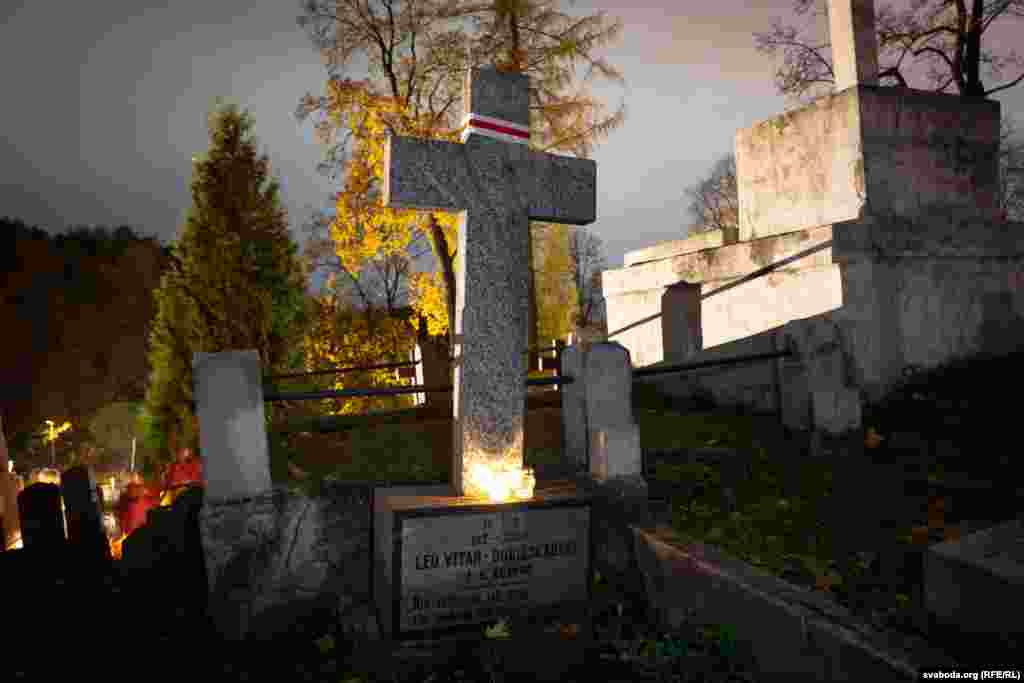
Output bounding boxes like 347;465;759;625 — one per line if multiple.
925;519;1024;634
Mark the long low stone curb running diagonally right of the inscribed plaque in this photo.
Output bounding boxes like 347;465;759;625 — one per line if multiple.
633;527;956;681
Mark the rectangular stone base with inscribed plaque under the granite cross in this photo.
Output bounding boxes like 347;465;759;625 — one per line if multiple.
373;482;593;644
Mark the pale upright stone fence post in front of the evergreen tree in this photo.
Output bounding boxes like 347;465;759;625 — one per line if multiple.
193;350;270;500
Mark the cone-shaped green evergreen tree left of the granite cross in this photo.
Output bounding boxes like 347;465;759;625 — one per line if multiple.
140;100;309;471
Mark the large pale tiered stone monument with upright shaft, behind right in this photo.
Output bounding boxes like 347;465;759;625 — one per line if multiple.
602;0;1011;432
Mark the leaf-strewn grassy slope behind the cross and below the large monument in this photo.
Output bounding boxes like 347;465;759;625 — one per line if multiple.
266;354;1024;680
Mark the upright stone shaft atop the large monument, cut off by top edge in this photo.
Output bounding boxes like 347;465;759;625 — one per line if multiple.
828;0;879;92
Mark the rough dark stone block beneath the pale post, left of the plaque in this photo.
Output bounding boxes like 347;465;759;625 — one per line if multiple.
200;481;371;639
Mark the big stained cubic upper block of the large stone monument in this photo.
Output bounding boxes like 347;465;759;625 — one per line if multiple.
736;85;999;241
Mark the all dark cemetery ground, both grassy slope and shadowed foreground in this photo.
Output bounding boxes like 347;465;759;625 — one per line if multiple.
5;359;1024;683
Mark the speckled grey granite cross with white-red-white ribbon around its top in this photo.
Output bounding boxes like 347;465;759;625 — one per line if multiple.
384;67;597;496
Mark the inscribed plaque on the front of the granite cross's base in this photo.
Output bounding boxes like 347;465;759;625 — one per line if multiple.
395;502;590;632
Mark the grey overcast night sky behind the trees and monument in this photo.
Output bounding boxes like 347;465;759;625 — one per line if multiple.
0;0;1024;286
